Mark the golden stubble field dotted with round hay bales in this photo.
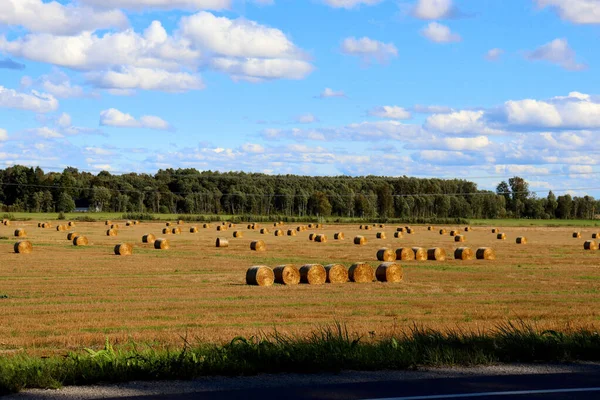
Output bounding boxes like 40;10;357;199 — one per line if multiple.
0;221;600;354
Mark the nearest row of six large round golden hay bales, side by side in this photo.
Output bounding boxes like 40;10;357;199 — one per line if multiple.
246;262;403;286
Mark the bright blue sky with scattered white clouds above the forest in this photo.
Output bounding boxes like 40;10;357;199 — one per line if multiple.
0;0;600;197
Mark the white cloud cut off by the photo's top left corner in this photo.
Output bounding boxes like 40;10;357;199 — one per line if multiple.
0;0;128;35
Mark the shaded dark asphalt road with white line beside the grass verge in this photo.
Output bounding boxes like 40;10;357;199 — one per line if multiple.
6;364;600;400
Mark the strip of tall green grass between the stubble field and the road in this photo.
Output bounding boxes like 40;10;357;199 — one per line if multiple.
0;322;600;394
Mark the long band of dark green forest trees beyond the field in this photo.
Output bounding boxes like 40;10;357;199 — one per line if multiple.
0;165;600;219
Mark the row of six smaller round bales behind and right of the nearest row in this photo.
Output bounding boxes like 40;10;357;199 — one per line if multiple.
377;247;496;262
